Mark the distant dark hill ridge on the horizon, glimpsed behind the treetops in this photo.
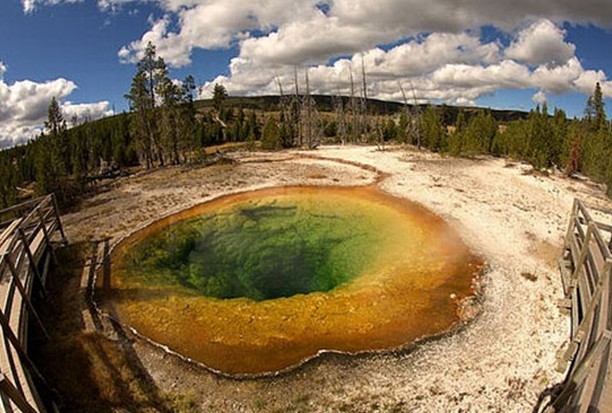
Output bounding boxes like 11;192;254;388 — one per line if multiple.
195;95;529;125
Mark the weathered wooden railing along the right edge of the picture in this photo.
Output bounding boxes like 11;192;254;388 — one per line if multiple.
546;200;612;413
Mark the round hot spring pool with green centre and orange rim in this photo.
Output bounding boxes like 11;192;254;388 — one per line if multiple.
100;187;481;375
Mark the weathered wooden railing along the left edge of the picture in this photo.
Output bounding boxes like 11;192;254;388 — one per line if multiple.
0;195;66;413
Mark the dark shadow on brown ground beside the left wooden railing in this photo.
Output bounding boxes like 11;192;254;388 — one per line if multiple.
30;243;195;413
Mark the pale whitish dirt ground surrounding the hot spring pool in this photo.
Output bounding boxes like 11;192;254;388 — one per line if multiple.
41;147;612;412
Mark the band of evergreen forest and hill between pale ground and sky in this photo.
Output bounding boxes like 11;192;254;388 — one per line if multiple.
0;63;612;212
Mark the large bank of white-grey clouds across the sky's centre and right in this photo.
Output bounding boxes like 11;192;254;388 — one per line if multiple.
16;0;612;121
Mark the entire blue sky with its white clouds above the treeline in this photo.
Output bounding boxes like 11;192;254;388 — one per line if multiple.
0;0;612;147
